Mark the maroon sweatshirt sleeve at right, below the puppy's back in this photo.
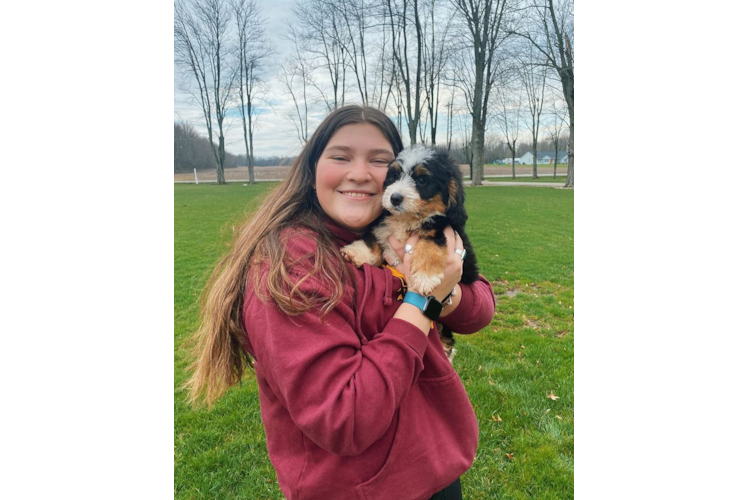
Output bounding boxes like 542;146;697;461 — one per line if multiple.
439;276;496;334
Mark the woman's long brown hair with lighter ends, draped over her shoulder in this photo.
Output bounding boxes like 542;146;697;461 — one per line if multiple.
182;105;403;407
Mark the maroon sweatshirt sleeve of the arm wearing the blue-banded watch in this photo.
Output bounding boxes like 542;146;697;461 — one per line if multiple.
244;232;428;455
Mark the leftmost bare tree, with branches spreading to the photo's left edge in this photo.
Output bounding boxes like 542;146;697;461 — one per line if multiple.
174;0;236;184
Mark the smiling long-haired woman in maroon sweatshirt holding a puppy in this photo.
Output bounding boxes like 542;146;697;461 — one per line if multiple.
187;106;495;500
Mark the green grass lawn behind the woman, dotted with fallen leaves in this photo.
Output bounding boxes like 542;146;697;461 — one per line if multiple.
174;184;576;500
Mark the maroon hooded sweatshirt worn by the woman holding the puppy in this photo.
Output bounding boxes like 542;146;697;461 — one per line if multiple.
244;222;495;500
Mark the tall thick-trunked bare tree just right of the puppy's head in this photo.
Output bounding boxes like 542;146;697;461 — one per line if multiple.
452;0;508;186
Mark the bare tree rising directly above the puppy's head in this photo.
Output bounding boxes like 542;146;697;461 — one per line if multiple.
386;0;423;144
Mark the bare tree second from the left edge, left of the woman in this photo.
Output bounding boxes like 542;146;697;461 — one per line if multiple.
231;0;273;184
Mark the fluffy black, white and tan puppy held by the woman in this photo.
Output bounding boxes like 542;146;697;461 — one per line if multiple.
341;144;478;361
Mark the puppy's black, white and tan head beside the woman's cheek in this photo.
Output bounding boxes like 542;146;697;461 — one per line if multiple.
382;144;457;219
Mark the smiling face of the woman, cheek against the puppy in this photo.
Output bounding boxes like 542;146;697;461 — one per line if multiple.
315;123;395;232
